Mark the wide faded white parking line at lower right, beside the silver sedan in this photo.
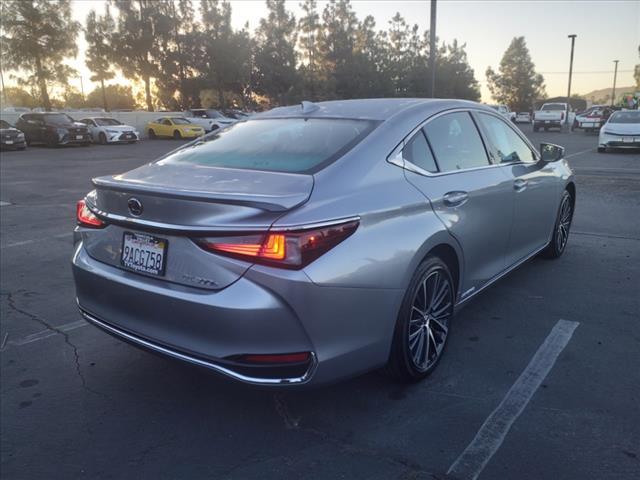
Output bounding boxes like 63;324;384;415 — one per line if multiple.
447;320;578;480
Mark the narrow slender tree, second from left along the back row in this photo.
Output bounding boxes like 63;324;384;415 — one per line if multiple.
84;7;115;112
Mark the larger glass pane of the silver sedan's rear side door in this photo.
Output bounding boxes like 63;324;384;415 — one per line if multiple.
424;112;489;172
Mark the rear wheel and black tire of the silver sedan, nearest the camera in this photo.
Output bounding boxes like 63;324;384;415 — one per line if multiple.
385;256;455;383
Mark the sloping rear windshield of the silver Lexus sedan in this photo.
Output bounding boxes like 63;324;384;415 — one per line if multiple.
160;118;375;173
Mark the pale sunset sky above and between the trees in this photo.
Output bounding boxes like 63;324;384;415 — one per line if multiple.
23;0;640;102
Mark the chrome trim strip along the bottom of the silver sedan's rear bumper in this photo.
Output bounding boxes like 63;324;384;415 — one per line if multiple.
76;308;318;385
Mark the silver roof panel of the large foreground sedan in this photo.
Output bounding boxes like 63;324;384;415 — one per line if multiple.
252;98;486;121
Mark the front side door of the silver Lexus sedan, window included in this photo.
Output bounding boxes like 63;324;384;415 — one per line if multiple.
475;112;560;265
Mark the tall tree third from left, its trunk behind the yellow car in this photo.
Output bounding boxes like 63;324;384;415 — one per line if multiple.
110;0;170;112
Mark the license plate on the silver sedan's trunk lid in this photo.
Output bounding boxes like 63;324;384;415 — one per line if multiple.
120;232;168;277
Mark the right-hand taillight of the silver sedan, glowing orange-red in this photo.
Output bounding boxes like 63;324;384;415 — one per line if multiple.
194;220;359;269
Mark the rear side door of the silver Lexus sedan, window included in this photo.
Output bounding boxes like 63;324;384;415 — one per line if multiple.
403;111;513;299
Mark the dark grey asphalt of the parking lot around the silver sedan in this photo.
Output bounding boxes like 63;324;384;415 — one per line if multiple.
0;126;640;480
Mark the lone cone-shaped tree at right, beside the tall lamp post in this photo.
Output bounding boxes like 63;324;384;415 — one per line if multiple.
486;37;545;111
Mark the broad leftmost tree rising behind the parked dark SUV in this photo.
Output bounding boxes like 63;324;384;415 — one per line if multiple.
0;0;80;110
